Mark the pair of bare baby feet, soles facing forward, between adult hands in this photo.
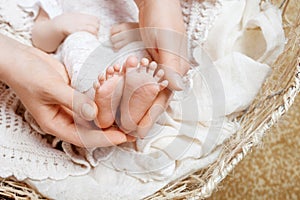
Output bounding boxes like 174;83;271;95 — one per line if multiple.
94;56;168;133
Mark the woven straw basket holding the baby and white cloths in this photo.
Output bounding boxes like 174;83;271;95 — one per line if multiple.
0;0;300;200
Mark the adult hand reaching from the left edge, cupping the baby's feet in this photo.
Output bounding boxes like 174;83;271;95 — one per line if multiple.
0;35;131;147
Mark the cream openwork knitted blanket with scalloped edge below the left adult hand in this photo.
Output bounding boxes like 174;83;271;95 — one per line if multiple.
0;83;90;180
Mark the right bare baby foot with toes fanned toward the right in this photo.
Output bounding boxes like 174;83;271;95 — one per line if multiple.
120;57;168;133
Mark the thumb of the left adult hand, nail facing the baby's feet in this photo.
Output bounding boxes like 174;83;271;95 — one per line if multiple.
54;83;98;121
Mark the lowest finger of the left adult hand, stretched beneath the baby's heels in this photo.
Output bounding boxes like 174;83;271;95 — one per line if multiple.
37;107;132;148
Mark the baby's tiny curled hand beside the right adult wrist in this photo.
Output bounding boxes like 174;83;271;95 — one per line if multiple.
111;22;142;50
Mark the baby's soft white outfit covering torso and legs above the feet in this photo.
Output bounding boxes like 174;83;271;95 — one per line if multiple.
18;0;138;89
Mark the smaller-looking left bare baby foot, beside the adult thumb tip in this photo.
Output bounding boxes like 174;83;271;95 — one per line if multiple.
94;65;124;128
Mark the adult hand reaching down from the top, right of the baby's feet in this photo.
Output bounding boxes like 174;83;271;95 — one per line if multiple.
135;0;189;137
